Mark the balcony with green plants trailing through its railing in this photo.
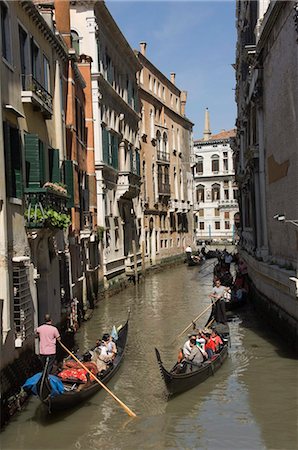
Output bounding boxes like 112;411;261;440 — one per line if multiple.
24;188;71;230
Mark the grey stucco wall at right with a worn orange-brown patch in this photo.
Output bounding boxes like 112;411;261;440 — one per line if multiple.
263;2;298;263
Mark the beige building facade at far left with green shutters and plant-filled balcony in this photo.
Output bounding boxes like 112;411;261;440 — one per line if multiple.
0;1;70;365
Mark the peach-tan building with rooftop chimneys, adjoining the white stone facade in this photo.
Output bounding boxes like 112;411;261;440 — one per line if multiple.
136;43;193;265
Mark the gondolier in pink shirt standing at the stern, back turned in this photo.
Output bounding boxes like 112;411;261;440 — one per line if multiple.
35;314;60;374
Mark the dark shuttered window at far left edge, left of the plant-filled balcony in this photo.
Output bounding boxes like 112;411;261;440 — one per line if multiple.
3;122;23;198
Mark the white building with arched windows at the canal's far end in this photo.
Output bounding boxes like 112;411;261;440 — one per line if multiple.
193;109;239;242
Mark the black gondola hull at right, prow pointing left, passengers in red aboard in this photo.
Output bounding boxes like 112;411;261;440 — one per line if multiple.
155;326;228;396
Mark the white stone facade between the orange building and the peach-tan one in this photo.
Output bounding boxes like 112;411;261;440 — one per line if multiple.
71;1;141;287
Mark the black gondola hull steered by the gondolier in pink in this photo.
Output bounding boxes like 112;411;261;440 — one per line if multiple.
24;320;128;412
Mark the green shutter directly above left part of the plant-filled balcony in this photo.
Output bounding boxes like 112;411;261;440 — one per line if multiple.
25;134;42;188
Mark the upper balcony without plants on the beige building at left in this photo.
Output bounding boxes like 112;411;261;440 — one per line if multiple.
22;75;53;119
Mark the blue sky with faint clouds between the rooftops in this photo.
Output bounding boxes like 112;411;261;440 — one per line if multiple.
106;0;236;139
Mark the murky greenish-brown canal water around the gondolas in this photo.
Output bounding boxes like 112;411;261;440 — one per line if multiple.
1;261;298;450
